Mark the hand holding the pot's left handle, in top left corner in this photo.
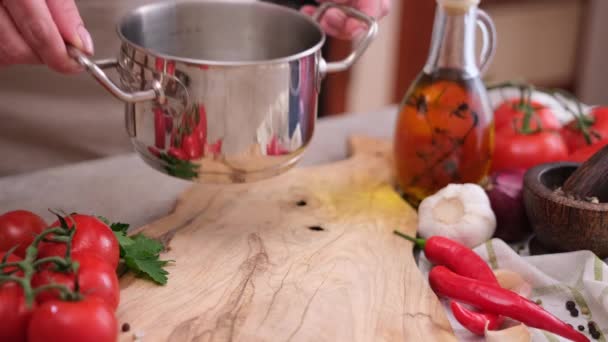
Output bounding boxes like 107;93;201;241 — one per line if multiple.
0;0;93;73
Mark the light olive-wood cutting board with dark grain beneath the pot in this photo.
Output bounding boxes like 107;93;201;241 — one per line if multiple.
118;137;456;342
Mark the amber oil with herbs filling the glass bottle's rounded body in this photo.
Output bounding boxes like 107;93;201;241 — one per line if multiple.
394;69;493;204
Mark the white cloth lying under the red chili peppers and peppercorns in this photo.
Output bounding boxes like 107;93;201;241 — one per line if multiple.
419;239;608;342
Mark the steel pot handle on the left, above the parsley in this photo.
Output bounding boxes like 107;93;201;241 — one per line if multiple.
67;46;165;103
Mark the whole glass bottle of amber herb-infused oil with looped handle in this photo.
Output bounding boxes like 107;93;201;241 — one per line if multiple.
394;0;494;205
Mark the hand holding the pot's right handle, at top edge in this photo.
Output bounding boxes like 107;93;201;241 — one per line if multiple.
301;0;391;39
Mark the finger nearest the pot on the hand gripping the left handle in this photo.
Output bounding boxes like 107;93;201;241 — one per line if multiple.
47;0;94;55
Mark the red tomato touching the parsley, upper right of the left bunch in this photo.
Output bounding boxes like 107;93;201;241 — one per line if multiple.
38;214;120;269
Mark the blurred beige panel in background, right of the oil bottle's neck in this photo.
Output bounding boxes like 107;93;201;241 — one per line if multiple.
485;0;583;85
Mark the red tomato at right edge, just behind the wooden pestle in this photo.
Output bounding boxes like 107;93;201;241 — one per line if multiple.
560;107;608;153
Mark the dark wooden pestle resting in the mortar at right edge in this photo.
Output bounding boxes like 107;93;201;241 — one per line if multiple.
562;145;608;203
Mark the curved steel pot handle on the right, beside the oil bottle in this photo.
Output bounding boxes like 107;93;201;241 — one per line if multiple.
313;2;378;74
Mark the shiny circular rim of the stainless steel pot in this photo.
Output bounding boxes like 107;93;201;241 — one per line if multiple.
116;0;327;67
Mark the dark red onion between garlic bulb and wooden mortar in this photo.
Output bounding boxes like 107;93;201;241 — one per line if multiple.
486;169;532;242
